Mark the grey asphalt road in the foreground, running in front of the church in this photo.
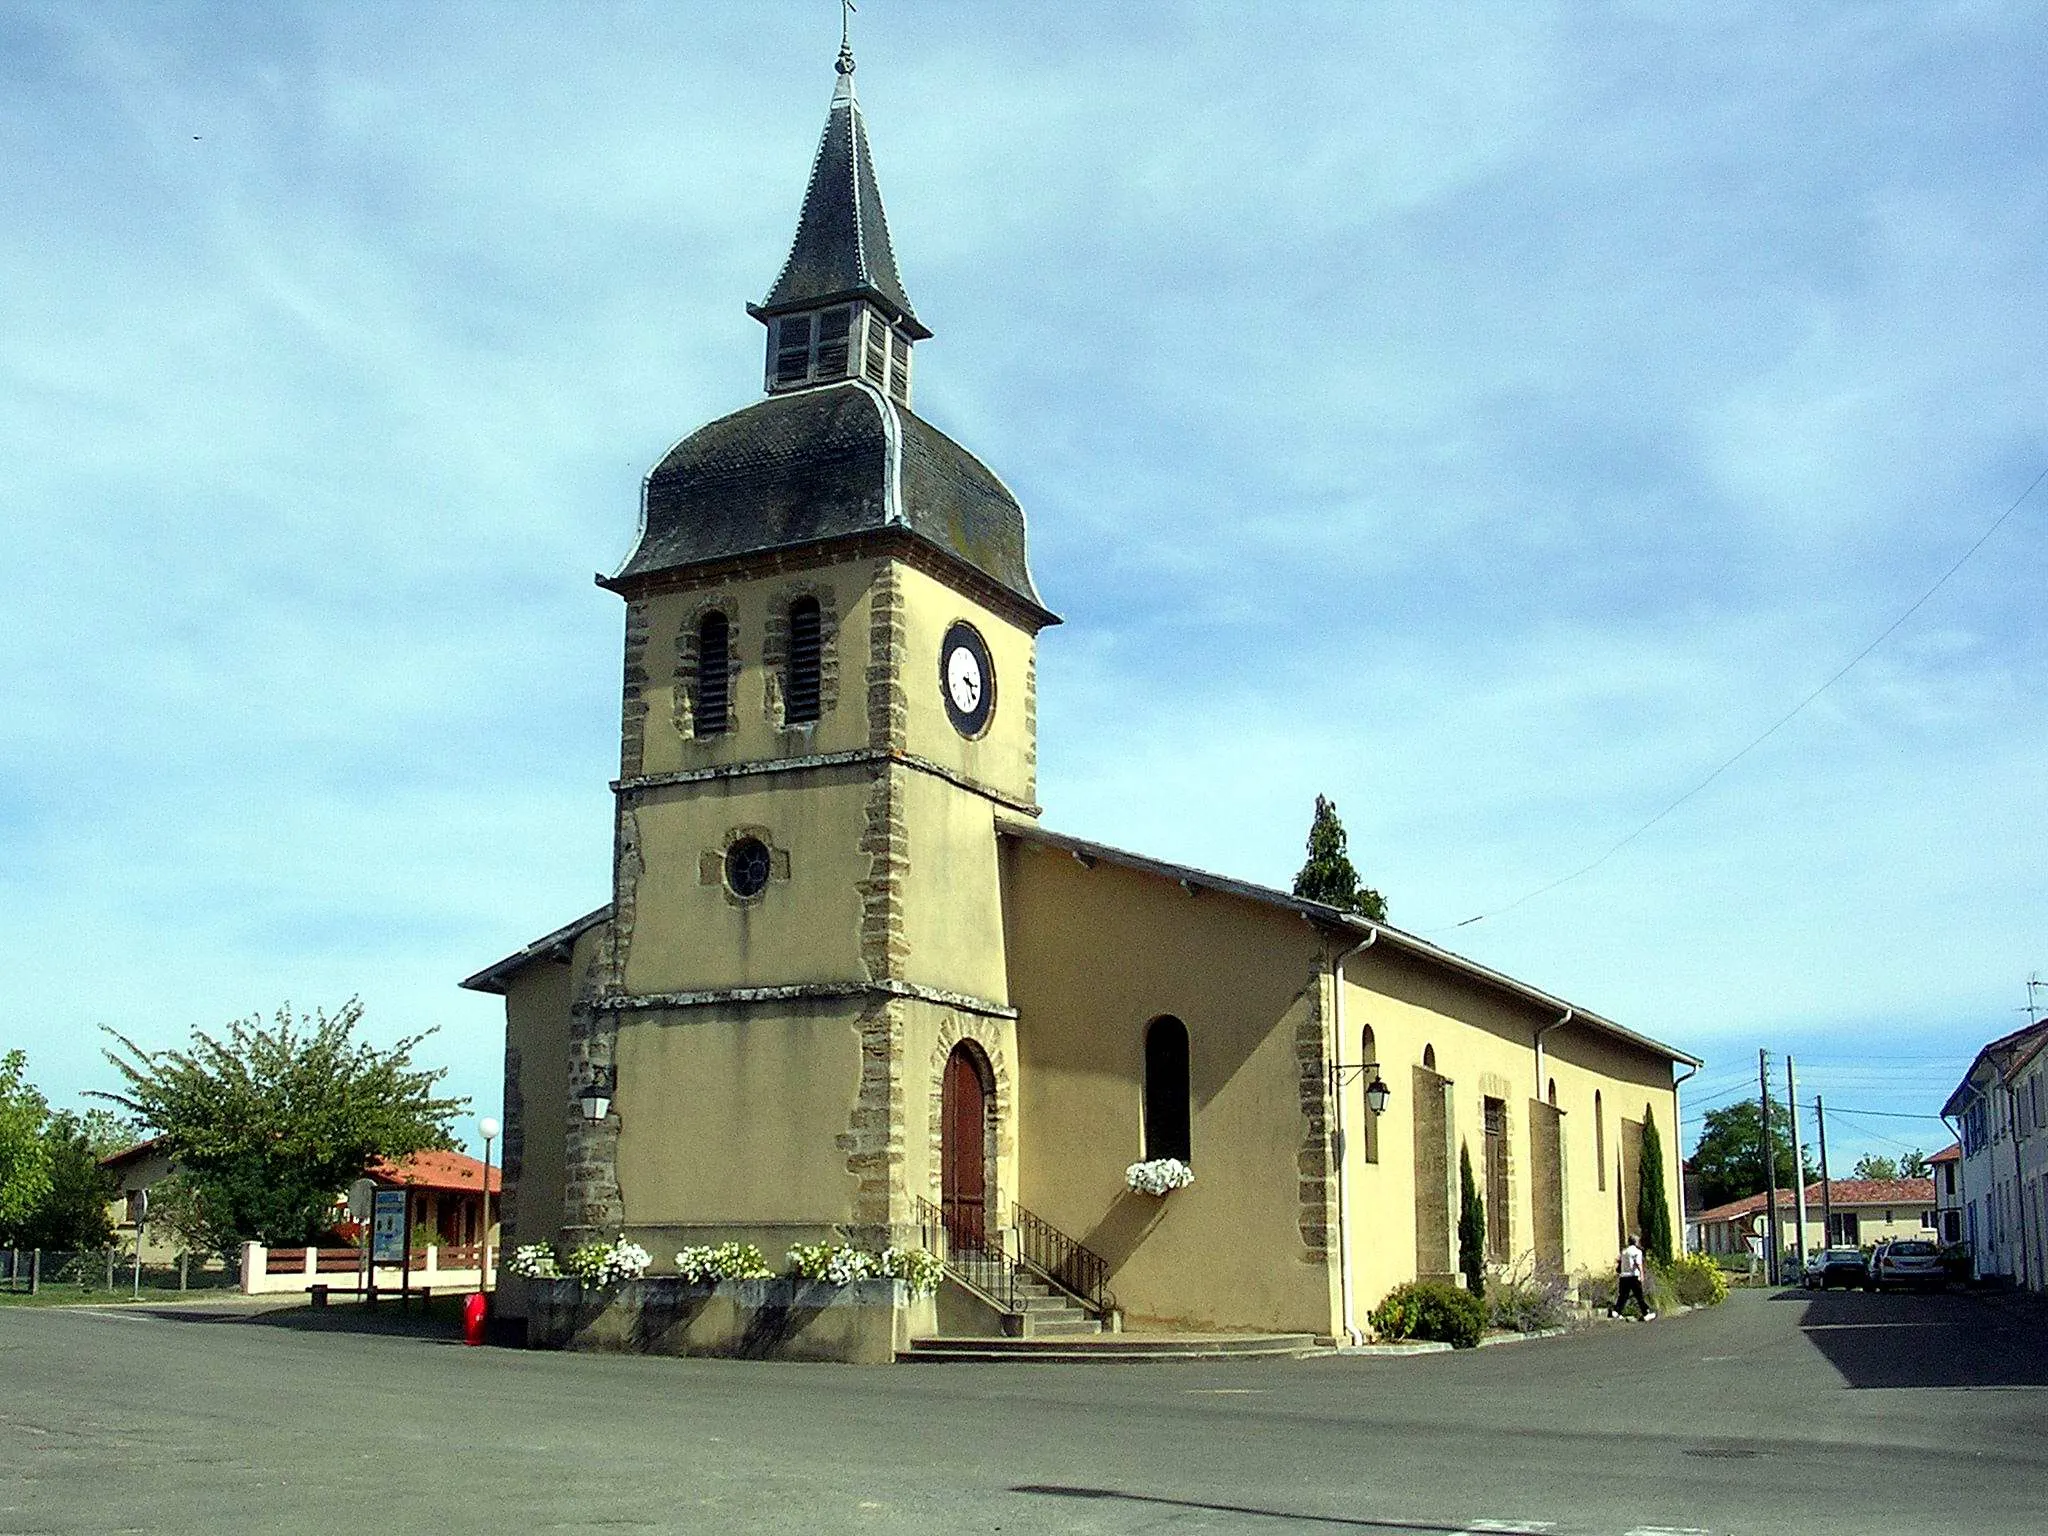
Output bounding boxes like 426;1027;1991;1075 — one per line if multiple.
0;1292;2048;1536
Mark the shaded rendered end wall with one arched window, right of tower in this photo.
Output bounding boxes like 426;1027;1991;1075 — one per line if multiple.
1004;844;1333;1335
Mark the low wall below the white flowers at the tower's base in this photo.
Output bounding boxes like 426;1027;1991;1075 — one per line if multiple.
524;1276;938;1366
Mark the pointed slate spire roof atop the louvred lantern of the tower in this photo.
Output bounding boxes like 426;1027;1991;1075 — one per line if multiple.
754;49;932;338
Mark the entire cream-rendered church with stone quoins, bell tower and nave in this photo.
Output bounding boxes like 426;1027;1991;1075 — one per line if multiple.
463;39;1698;1339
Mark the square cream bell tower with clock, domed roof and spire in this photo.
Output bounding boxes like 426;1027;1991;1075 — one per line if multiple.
565;45;1059;1255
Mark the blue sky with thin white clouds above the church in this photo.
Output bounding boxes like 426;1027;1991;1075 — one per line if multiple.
0;0;2048;1165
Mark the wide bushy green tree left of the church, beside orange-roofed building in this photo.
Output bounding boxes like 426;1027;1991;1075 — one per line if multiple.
98;997;469;1255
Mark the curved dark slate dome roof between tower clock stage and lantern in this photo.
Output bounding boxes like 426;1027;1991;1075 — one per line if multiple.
606;379;1057;623
